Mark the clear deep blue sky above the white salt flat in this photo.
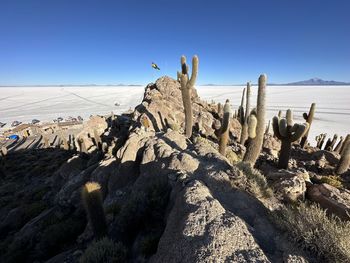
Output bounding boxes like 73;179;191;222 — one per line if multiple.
0;0;350;85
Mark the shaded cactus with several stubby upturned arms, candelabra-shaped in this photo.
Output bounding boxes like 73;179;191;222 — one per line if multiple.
272;110;309;169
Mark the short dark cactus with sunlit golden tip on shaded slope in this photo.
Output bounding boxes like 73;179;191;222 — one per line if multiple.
81;182;107;239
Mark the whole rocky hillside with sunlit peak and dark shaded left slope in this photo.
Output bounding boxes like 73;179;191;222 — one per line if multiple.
0;77;350;263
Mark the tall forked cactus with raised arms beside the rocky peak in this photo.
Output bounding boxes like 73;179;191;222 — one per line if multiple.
177;56;198;138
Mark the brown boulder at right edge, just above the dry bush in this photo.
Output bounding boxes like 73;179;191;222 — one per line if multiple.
307;184;350;220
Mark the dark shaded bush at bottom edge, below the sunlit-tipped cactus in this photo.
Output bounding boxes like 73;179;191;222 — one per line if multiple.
79;237;127;263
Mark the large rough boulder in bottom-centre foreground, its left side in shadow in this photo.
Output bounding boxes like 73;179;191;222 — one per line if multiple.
150;181;269;262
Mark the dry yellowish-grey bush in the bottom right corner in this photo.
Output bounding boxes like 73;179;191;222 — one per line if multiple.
274;203;350;262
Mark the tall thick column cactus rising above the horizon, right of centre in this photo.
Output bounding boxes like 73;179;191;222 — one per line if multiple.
243;74;267;166
